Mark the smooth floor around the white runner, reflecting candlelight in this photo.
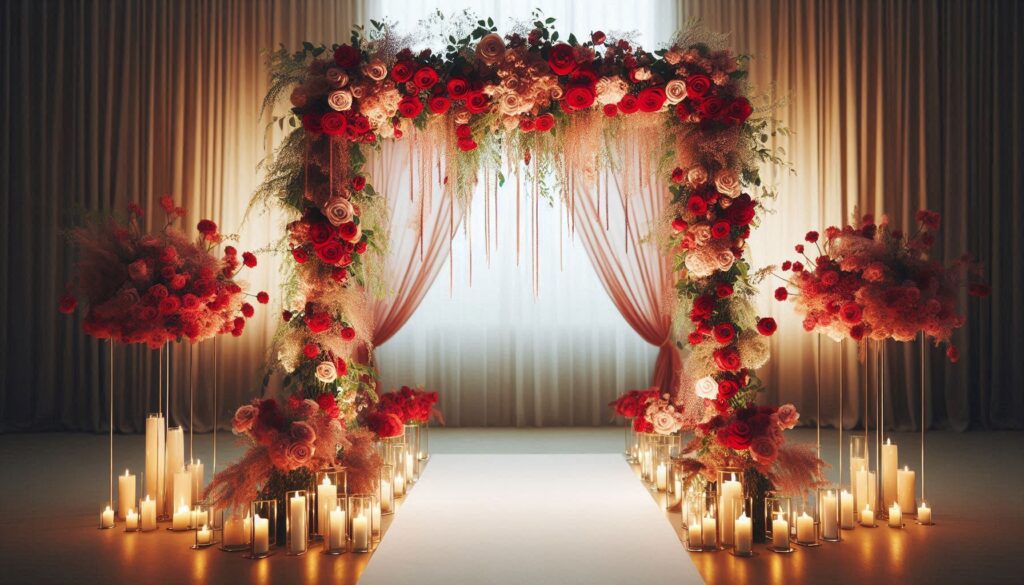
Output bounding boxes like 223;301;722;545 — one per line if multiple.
0;428;1024;585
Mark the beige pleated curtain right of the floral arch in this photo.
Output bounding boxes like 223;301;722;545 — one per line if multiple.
680;0;1024;429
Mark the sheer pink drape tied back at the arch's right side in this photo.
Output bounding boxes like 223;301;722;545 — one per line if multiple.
570;133;682;392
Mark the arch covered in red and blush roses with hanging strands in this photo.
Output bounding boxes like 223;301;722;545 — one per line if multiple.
212;13;816;508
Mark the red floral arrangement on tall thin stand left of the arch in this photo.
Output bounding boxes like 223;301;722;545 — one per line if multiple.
59;196;270;348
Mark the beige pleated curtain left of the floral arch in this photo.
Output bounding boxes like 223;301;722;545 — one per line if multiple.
0;0;364;431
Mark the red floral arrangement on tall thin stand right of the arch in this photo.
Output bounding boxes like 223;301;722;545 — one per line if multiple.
775;210;989;362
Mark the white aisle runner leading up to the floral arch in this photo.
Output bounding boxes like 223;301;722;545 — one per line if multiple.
359;454;702;585
